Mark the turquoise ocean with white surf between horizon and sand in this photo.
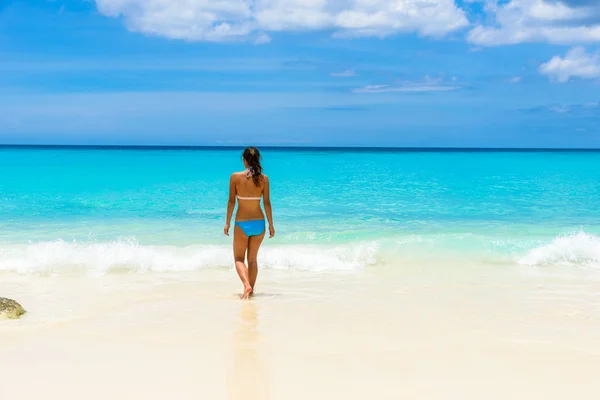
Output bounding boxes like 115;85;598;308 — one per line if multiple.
0;147;600;274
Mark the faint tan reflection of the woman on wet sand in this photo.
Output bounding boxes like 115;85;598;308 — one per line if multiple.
227;300;269;400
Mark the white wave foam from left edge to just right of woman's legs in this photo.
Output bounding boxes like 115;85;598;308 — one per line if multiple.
0;239;376;274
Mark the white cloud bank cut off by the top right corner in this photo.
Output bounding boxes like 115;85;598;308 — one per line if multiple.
468;0;600;46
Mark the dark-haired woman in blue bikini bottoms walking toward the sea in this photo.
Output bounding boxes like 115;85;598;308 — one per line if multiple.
224;147;275;299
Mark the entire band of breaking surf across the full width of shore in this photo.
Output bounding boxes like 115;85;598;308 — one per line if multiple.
0;232;600;275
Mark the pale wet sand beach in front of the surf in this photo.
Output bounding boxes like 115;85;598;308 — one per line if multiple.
0;267;600;400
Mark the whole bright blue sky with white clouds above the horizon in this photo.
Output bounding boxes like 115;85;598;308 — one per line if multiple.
0;0;600;147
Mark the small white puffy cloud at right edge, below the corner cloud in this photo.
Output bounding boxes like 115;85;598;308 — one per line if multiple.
540;47;600;83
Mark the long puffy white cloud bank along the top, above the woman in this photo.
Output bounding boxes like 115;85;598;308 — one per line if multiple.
95;0;468;42
